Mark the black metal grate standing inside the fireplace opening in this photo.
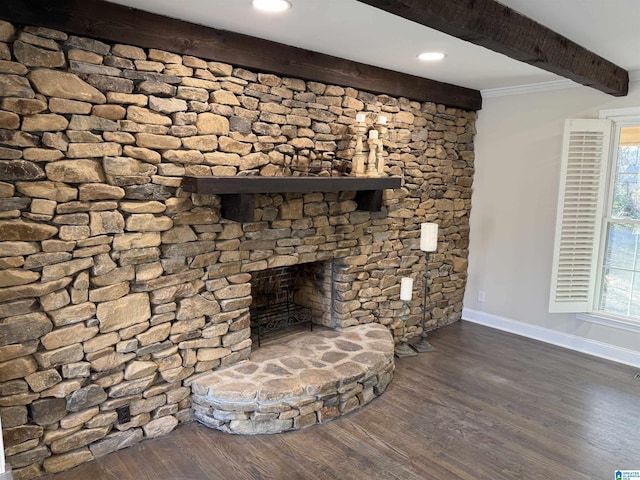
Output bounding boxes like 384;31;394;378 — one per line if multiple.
249;289;313;346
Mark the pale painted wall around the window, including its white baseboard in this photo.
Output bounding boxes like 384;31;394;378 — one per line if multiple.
463;82;640;366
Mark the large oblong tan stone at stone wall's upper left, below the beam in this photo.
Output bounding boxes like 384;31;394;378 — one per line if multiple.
28;69;107;104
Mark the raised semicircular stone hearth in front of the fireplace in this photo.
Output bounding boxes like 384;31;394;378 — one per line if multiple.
192;323;394;434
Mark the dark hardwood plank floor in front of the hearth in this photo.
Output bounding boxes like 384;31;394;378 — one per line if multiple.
41;322;640;480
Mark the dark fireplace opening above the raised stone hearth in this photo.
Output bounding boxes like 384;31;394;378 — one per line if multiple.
250;262;333;347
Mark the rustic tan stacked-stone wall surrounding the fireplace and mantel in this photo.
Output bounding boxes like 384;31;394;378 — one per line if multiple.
0;21;475;479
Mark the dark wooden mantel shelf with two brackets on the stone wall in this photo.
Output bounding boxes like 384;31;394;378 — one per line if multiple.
182;176;402;222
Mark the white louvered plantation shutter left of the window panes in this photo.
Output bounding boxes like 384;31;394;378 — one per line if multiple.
549;120;612;312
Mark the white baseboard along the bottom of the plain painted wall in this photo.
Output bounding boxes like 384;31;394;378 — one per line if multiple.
462;308;640;367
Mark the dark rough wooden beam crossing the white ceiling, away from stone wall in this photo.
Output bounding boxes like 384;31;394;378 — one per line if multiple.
358;0;629;96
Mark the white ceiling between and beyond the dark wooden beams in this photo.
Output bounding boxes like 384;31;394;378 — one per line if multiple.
111;0;640;91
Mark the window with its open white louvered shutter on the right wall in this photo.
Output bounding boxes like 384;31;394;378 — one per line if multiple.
549;110;640;324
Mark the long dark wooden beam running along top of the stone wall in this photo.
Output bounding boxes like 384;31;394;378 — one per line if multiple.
0;0;482;110
